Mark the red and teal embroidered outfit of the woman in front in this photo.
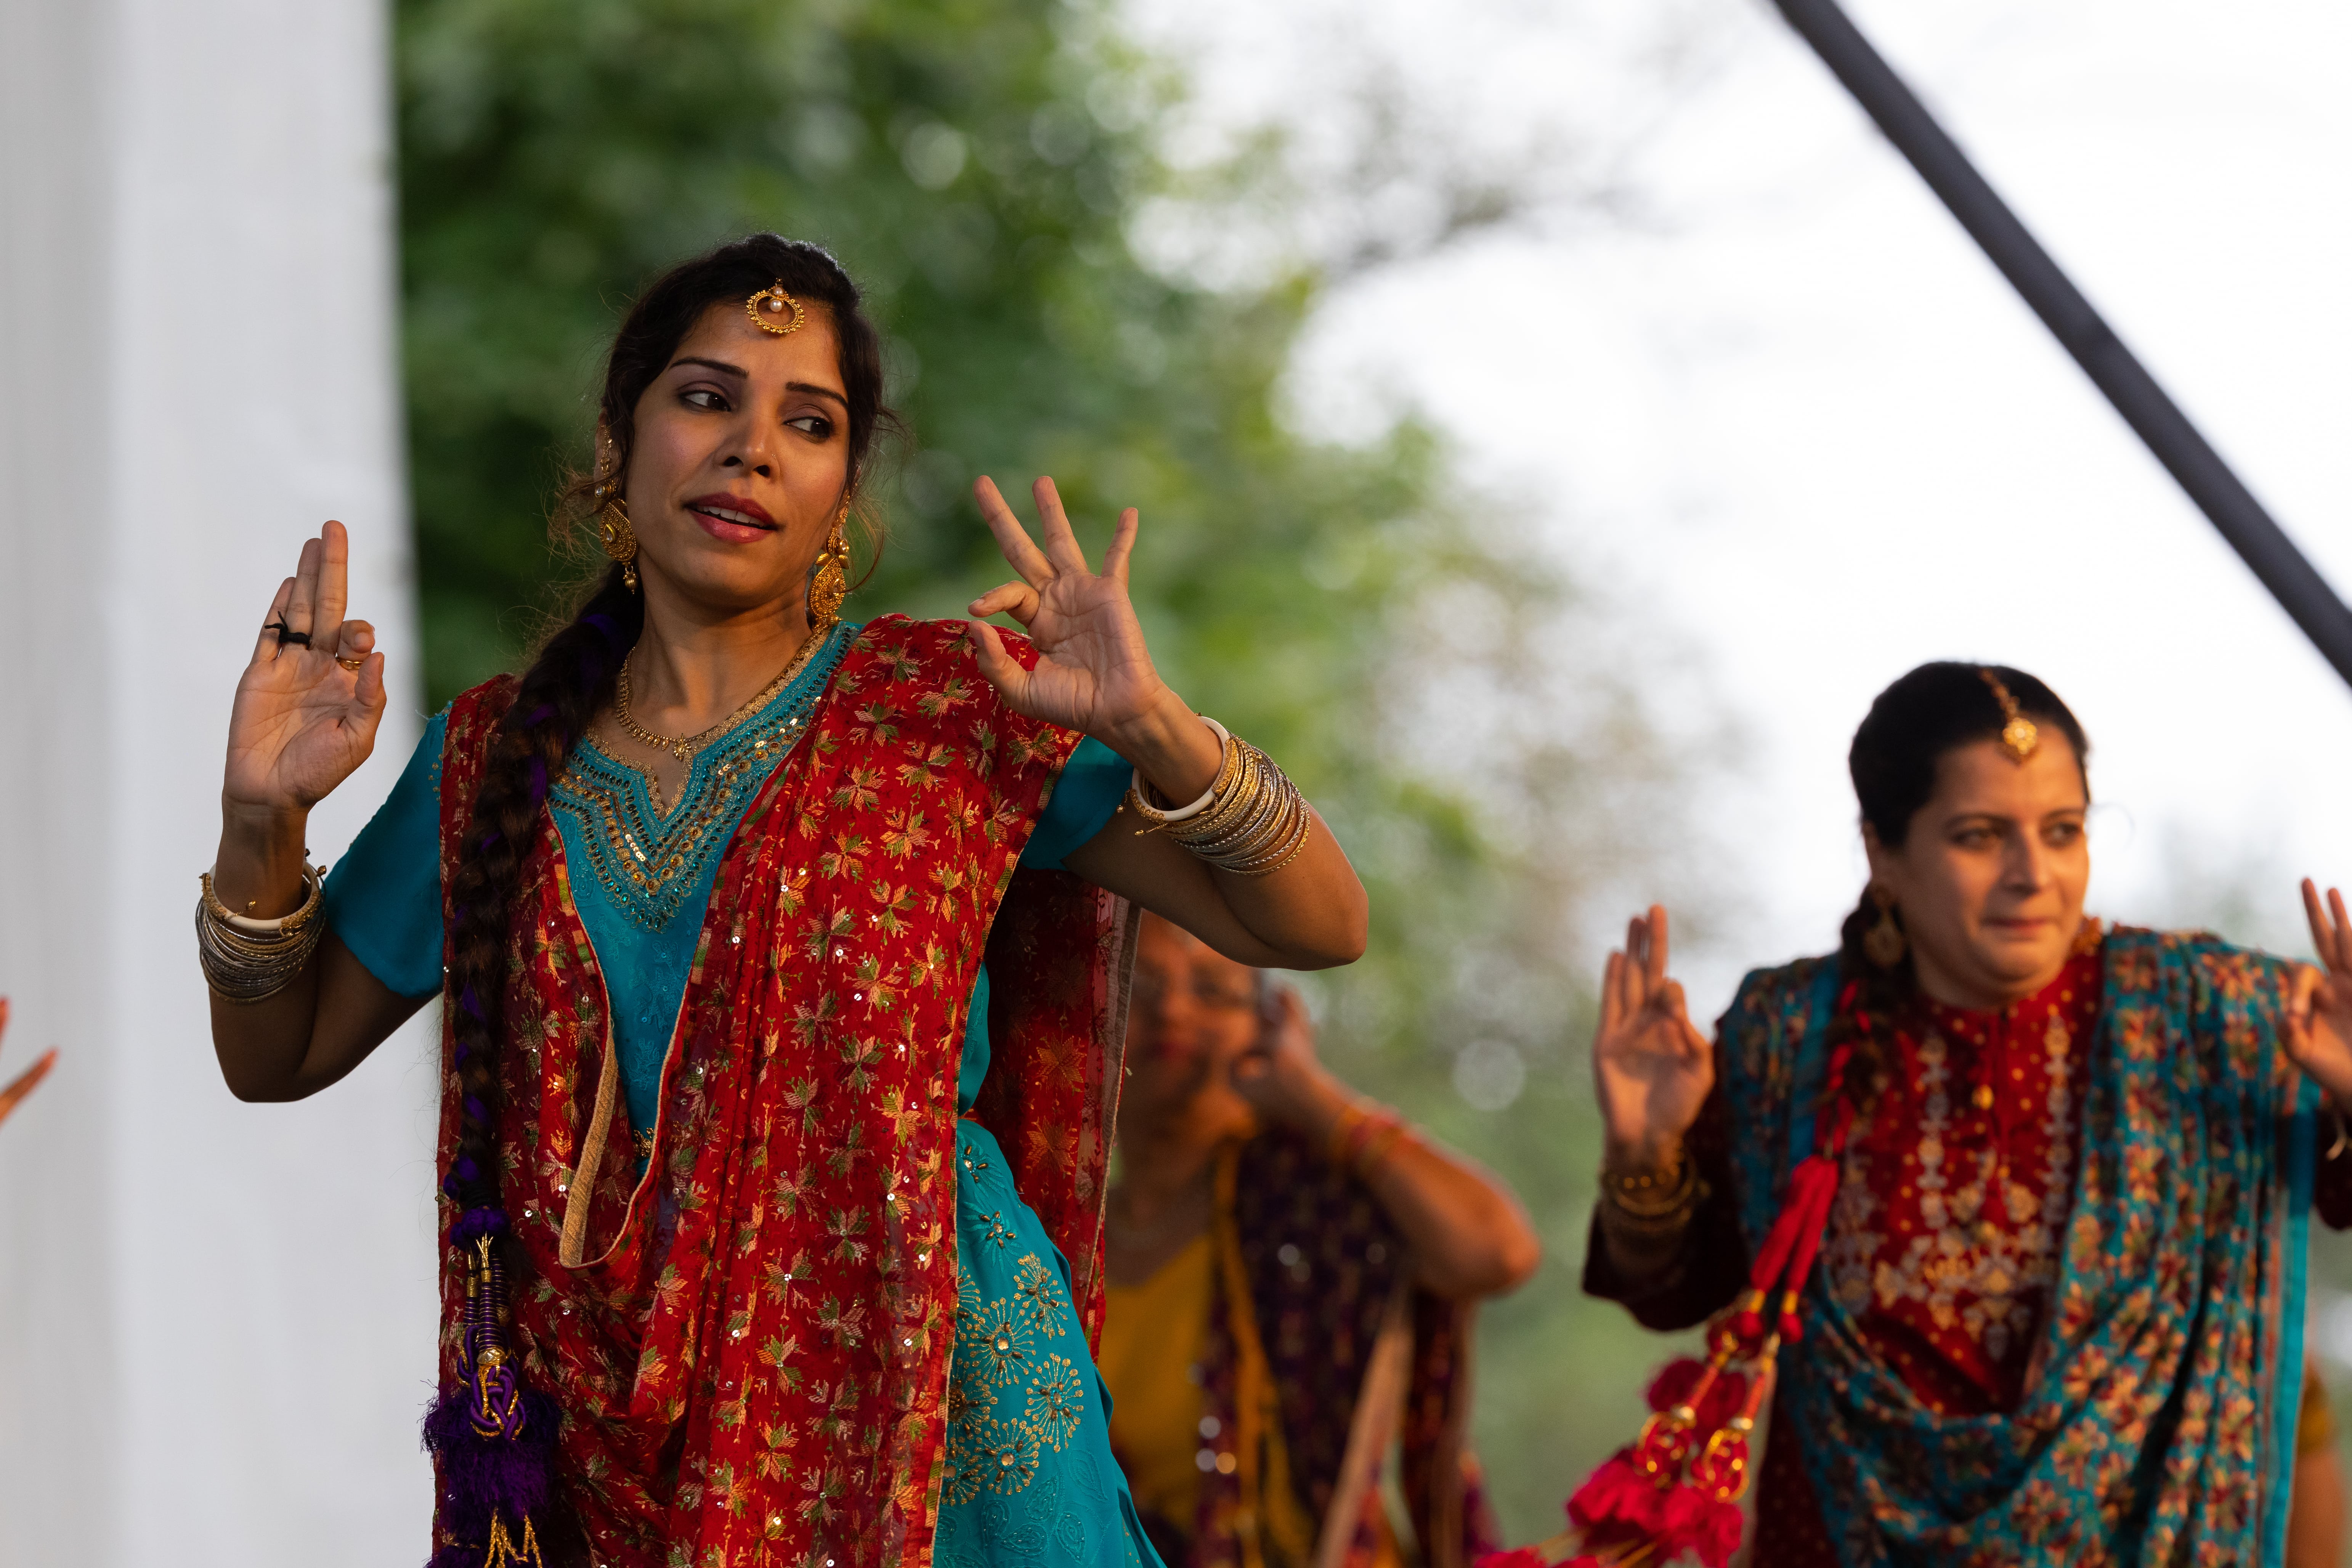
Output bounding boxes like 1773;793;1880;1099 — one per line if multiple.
329;616;1152;1568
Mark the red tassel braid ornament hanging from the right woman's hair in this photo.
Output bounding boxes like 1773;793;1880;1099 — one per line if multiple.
1477;985;1870;1568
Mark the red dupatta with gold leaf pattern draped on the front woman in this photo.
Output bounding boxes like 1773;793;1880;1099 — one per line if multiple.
440;616;1129;1568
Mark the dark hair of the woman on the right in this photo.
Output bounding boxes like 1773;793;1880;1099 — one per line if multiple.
1830;661;2091;1098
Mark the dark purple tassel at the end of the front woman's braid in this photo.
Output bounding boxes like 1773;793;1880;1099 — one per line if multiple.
426;1208;557;1568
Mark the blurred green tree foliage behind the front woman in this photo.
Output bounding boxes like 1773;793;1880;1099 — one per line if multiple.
395;0;1712;1535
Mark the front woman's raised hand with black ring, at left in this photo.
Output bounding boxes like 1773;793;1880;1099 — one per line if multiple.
221;522;386;820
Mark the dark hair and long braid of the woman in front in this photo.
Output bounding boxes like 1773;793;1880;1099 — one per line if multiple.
442;235;898;1211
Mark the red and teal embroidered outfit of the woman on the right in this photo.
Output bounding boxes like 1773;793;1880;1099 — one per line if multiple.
1585;926;2352;1568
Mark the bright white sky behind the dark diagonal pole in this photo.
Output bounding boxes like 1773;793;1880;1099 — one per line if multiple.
1146;0;2352;1013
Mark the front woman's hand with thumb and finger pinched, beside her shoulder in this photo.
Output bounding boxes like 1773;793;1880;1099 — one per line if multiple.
971;477;1169;743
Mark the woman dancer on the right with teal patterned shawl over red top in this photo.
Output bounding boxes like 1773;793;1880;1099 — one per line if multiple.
1571;663;2352;1568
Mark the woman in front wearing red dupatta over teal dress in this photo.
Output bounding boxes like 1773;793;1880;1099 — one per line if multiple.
212;235;1364;1568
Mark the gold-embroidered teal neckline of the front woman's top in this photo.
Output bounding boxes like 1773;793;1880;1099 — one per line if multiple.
548;625;854;931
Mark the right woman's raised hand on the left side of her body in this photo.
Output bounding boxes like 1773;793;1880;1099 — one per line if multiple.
1592;905;1715;1166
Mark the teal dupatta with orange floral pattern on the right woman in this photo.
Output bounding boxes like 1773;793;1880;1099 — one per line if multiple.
1721;929;2319;1568
